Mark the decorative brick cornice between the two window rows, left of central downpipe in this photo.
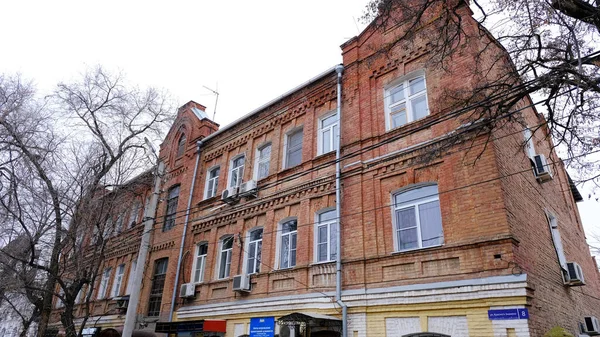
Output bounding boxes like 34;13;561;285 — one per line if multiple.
192;176;335;233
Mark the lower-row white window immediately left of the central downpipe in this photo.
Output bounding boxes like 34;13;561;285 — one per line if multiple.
315;210;338;262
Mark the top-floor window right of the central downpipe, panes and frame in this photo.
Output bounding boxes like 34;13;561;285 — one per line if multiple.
385;75;429;129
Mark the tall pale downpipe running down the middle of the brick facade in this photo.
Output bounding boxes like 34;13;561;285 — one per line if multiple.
335;64;348;337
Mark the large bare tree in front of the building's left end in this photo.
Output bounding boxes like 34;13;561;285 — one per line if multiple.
0;67;173;336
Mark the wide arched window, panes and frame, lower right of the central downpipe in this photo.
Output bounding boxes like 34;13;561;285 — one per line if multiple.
393;185;444;251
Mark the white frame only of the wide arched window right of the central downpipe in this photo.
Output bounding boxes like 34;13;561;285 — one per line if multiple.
391;184;444;252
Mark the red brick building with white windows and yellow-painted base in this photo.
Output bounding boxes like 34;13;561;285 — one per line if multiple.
51;1;600;337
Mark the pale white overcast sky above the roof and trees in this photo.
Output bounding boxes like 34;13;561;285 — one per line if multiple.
0;0;600;251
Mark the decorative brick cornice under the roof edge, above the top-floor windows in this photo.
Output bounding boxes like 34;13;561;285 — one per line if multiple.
204;87;337;161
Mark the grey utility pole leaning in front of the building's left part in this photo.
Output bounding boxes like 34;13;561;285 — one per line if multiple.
122;160;165;336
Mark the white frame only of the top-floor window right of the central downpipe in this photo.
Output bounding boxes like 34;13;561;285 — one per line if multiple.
383;70;431;131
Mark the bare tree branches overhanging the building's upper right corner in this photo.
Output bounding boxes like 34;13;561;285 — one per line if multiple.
364;0;600;186
